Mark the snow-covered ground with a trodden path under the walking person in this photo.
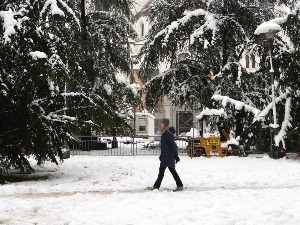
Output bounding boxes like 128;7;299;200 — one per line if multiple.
0;156;300;225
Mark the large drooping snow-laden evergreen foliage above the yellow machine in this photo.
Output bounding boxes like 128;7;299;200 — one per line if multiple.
140;0;270;108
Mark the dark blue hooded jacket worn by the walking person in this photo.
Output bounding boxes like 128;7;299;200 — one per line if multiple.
160;127;178;168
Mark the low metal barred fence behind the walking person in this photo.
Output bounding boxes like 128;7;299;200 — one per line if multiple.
69;136;188;156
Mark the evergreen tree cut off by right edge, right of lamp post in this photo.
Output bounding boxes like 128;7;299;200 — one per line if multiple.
274;0;300;151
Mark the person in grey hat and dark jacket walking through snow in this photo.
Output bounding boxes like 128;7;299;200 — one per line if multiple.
149;118;183;191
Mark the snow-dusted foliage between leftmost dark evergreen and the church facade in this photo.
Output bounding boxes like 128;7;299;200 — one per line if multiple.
81;6;140;134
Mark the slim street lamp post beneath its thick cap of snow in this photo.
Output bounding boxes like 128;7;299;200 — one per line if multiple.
264;29;279;158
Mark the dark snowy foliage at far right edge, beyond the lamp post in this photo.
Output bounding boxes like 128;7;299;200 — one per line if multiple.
275;3;300;150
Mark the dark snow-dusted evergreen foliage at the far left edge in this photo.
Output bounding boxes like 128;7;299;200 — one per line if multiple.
0;1;84;170
